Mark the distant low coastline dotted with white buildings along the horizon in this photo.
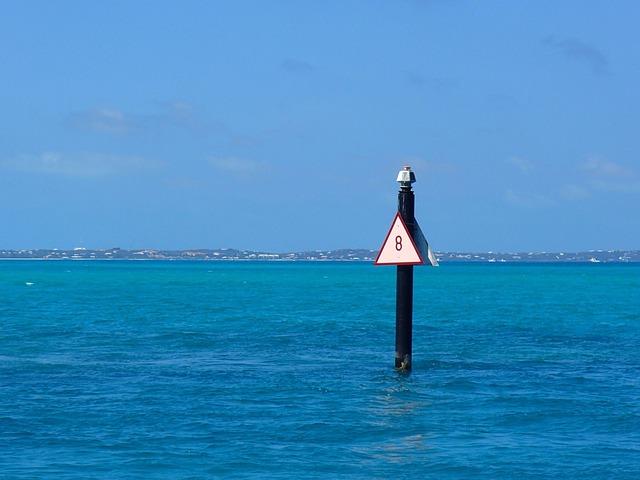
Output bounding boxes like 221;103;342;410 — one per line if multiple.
0;247;640;263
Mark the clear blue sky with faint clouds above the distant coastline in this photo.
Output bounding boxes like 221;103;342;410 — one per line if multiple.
0;0;640;251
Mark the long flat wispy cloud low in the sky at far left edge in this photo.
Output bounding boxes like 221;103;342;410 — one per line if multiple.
0;152;159;178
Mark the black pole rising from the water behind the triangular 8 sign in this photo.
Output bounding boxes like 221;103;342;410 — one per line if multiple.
395;178;415;371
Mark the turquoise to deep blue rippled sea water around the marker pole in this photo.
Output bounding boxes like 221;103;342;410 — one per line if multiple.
0;261;640;479
